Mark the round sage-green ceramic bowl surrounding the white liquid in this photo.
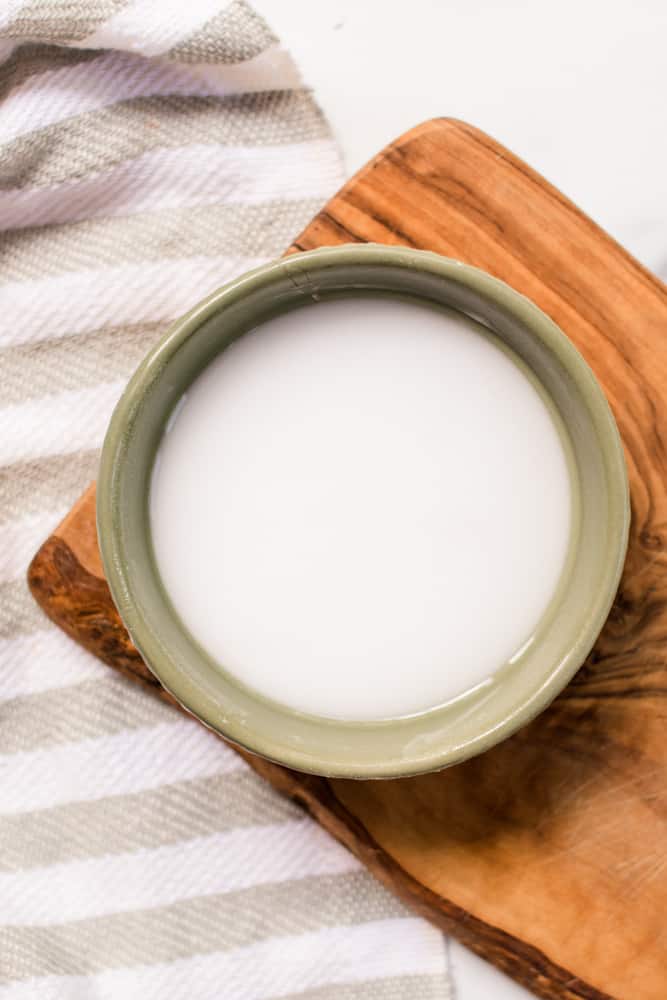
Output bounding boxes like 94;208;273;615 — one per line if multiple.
97;245;629;778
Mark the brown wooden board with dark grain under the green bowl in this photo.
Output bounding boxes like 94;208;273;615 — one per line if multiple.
29;119;667;1000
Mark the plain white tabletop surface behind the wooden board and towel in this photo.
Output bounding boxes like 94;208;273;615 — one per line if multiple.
253;0;667;1000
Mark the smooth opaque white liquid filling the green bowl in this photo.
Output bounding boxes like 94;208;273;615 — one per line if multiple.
151;297;571;720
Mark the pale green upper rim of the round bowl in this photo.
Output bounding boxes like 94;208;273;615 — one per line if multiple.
97;244;630;778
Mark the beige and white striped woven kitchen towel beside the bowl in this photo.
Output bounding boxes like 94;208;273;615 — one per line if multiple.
0;0;449;1000
